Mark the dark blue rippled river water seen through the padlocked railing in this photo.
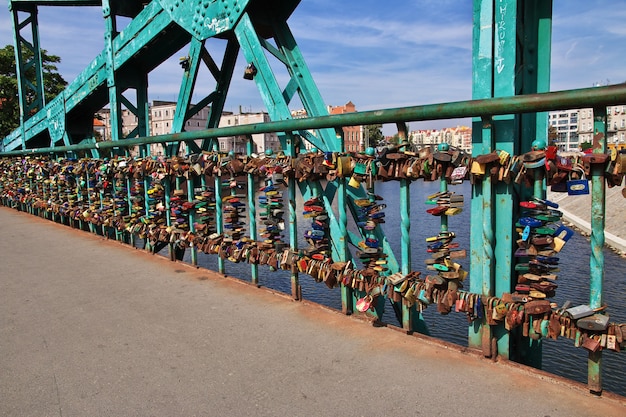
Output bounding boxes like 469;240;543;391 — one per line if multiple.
186;181;626;395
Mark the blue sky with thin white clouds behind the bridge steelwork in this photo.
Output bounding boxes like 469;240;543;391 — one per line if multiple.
0;0;626;134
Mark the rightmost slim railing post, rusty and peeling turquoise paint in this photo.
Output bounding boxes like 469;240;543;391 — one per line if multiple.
587;108;607;393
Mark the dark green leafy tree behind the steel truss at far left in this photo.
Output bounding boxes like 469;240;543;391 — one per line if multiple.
0;45;67;138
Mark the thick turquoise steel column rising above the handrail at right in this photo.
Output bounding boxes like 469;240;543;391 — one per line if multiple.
469;0;552;367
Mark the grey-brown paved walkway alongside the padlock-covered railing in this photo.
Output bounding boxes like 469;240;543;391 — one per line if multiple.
0;207;626;417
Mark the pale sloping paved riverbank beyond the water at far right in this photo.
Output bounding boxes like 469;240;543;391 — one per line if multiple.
547;183;626;257
